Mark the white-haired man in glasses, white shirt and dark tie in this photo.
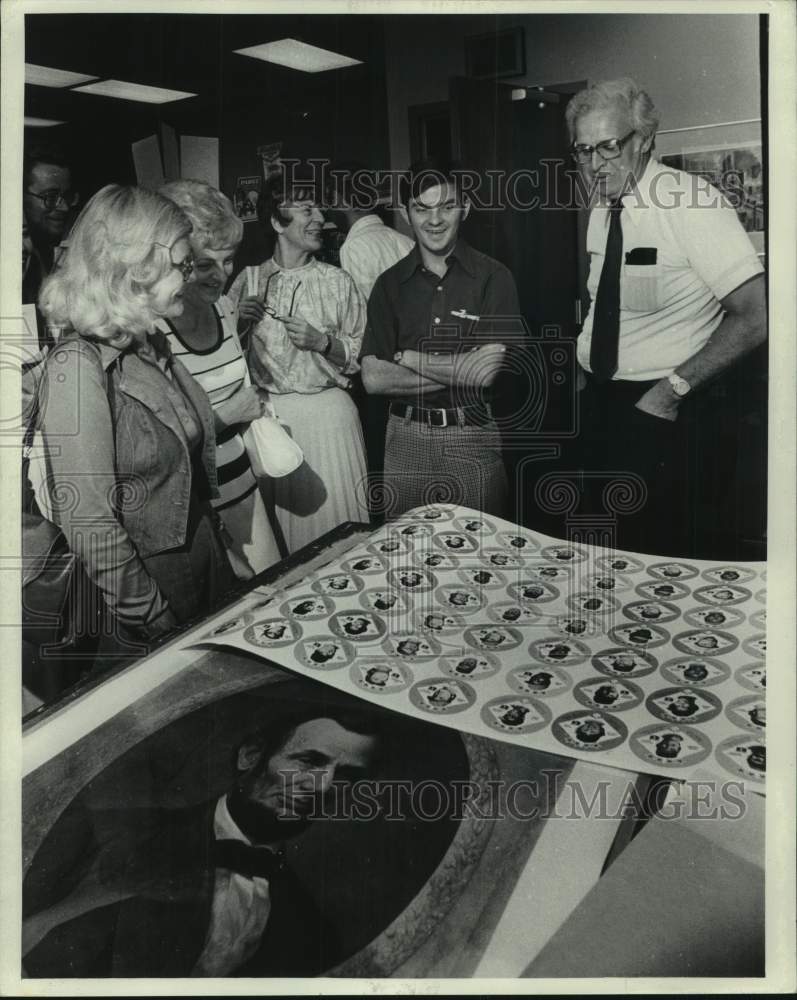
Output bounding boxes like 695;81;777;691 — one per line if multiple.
565;78;766;557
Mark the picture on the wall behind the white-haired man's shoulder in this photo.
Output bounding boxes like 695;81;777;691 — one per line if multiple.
656;121;766;257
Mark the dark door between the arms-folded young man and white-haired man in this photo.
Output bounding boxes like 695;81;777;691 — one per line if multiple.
450;78;580;523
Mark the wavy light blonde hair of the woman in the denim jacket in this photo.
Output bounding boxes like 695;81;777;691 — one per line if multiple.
39;184;191;348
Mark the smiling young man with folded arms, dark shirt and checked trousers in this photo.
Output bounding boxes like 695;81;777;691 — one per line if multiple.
362;160;520;517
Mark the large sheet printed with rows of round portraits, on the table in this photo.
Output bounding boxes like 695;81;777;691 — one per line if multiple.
201;505;766;791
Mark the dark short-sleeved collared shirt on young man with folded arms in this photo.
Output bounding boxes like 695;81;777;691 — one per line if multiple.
362;240;524;407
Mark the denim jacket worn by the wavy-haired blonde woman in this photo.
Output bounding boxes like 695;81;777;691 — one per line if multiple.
39;333;218;625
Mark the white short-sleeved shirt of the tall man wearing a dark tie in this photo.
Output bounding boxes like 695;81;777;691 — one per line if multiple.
578;159;763;381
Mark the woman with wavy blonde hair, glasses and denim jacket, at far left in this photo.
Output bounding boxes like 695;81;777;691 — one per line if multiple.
39;184;234;665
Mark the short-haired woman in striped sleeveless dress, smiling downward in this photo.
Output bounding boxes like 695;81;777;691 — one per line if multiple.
160;180;279;579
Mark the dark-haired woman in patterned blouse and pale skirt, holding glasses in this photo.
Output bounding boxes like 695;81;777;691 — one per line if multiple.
229;168;367;552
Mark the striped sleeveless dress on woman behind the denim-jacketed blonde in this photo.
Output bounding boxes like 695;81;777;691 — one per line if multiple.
165;296;280;578
